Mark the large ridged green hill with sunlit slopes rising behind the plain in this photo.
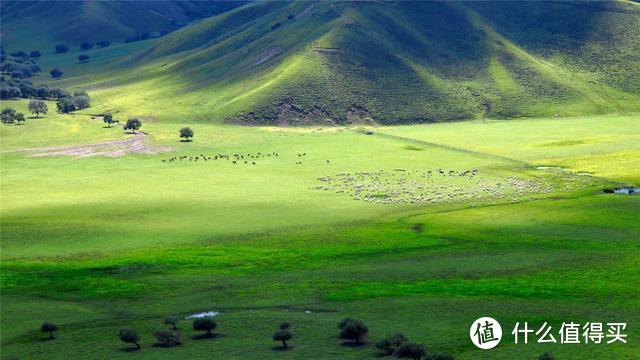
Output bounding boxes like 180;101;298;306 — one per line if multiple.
8;1;640;125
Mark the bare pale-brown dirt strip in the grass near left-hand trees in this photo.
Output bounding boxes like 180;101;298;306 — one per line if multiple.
16;133;171;158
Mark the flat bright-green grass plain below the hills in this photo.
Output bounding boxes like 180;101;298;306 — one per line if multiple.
0;97;640;359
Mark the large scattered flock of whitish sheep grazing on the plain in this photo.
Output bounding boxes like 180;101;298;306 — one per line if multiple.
313;168;605;205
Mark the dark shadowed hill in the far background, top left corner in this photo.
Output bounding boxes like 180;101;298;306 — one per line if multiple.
0;0;243;51
